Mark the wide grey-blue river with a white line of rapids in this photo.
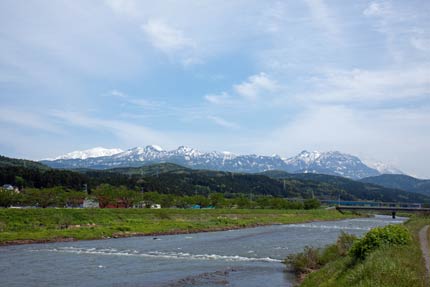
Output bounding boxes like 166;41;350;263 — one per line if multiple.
0;216;404;287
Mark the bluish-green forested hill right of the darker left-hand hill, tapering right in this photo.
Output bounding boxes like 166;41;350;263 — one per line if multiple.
97;163;429;202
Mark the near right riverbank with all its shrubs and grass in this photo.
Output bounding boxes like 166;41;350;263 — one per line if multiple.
285;216;430;287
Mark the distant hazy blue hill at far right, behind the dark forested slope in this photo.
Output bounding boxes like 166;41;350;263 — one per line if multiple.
360;174;430;196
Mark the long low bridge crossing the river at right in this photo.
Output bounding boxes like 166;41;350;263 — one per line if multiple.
336;202;430;218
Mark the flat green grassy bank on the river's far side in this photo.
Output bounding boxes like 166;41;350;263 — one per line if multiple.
0;208;357;245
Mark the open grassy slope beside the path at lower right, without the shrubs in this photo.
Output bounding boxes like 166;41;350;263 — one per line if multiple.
300;217;430;287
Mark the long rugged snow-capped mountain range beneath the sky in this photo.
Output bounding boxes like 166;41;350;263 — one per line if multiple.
42;145;396;179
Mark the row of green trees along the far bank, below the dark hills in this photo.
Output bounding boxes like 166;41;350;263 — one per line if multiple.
0;184;320;209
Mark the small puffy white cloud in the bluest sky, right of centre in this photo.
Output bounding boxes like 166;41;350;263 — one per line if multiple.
233;73;279;100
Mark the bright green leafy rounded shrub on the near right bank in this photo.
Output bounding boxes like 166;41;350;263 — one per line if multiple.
350;225;412;259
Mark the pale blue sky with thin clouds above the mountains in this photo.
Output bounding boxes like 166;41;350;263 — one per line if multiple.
0;0;430;178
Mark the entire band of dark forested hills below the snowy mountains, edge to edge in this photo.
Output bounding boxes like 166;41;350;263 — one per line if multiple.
0;155;430;205
